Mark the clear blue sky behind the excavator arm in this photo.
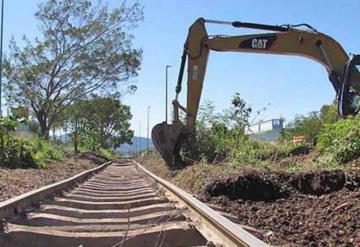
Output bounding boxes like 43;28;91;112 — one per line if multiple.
0;0;360;136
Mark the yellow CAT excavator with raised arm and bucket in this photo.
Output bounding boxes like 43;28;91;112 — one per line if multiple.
151;18;360;165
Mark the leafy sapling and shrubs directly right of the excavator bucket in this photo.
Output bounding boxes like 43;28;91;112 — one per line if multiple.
182;93;252;162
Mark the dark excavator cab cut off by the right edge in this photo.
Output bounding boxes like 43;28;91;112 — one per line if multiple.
338;55;360;117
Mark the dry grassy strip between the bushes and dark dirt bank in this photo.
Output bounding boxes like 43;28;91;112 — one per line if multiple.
137;146;360;193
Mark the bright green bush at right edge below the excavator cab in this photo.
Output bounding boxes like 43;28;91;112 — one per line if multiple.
317;116;360;163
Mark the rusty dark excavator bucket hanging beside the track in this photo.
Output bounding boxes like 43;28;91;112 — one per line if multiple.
151;122;182;166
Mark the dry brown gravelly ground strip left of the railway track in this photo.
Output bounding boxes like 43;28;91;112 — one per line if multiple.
0;153;106;202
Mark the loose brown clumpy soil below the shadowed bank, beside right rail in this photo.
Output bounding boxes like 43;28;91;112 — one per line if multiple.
209;189;360;247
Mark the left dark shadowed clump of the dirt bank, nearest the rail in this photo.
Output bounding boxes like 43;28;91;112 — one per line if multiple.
205;171;289;201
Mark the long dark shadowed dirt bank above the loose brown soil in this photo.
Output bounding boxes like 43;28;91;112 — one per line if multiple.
203;170;360;204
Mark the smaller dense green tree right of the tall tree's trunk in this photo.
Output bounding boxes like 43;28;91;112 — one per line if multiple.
64;95;134;152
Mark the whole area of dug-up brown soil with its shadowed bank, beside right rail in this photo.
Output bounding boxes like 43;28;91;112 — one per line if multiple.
201;169;360;246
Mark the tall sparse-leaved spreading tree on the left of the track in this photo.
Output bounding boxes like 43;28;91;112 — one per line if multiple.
4;0;143;139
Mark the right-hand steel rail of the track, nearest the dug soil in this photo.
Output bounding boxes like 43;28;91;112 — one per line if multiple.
134;161;268;247
